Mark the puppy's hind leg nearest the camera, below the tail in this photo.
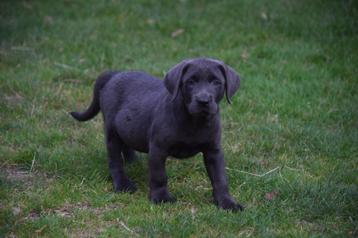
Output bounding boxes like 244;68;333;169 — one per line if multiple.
106;129;137;193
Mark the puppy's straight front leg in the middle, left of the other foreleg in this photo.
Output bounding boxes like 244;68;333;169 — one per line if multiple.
148;145;175;203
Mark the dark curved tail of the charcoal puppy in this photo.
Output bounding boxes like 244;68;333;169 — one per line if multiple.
70;71;118;121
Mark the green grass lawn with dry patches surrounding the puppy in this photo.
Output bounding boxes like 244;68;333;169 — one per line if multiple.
0;0;358;237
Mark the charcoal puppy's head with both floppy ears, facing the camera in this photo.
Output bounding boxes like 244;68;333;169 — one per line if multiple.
164;58;240;116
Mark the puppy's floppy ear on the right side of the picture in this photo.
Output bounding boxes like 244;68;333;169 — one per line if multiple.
217;61;240;104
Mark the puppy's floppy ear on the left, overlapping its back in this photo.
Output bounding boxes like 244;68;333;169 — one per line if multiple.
164;60;189;101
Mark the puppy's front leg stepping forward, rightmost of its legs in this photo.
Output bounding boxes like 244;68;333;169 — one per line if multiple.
203;149;243;211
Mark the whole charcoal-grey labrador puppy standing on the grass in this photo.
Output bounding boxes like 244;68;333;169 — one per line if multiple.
71;58;243;211
